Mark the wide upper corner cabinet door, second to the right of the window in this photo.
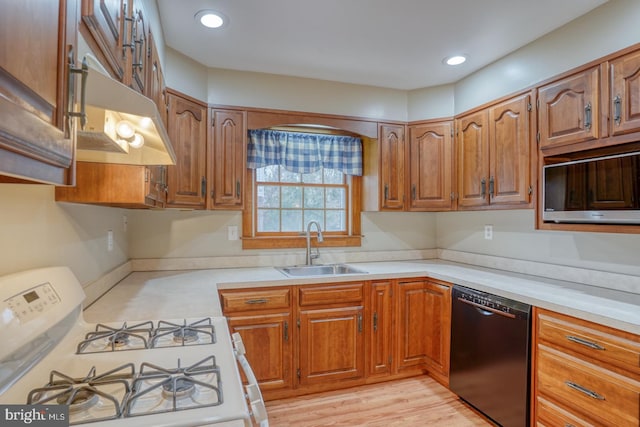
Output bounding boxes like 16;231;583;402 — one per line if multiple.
409;122;453;211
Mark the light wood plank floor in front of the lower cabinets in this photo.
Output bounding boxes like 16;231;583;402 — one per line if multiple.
267;375;493;427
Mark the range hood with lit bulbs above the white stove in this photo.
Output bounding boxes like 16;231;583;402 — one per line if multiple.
77;53;176;165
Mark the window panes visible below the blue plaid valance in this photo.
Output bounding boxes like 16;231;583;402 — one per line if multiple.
255;165;349;236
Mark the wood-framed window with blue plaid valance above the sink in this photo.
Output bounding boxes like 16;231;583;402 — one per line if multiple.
242;130;362;249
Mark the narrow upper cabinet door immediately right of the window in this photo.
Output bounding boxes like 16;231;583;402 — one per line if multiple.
378;124;405;210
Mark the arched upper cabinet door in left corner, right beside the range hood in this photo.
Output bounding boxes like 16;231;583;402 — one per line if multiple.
167;93;207;209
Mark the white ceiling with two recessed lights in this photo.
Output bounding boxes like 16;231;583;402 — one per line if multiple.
157;0;607;90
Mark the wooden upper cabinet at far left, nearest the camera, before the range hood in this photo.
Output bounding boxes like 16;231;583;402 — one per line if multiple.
0;0;80;185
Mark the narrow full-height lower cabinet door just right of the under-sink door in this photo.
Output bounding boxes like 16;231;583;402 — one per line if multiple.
369;281;393;375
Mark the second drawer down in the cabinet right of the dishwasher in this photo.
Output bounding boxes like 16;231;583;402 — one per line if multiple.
536;345;640;427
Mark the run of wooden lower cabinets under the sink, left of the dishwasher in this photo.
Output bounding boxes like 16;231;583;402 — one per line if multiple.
219;278;451;400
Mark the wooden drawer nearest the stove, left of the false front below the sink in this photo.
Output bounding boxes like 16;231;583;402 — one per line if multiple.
220;288;291;314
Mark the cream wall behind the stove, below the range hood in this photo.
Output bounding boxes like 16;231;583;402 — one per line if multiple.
0;184;129;284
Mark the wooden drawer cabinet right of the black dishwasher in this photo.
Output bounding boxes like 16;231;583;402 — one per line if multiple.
533;308;640;427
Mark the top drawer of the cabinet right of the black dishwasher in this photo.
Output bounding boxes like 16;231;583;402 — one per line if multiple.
538;312;640;375
